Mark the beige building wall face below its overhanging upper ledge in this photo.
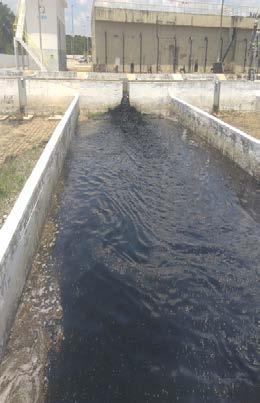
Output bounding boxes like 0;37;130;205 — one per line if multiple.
95;21;251;73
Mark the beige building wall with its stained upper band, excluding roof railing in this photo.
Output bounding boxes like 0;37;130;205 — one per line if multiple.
92;7;255;73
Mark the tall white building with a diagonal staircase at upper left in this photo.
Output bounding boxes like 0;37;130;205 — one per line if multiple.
14;0;67;71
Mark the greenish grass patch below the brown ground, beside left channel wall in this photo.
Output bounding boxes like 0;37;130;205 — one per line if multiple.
0;145;44;224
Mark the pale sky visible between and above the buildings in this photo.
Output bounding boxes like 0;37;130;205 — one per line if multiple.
2;0;259;35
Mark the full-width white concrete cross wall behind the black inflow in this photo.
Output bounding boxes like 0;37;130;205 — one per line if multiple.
0;73;260;115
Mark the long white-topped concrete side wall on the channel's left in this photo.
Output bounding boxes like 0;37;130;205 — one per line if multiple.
0;96;79;359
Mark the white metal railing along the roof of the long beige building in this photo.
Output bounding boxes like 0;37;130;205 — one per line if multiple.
94;0;260;18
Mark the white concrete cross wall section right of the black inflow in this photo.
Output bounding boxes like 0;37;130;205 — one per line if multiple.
129;80;260;114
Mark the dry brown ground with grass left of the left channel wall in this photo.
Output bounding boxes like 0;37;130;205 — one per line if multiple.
0;117;57;228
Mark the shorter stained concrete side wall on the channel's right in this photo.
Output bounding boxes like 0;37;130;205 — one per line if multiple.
171;97;260;181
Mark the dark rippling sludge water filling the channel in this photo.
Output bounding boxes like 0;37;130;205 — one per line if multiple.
47;105;260;403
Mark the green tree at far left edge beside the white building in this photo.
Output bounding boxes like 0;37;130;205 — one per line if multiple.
0;1;15;54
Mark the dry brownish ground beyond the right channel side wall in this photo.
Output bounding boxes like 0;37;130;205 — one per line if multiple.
218;112;260;140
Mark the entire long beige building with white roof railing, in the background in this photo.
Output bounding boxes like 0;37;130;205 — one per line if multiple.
92;0;260;74
